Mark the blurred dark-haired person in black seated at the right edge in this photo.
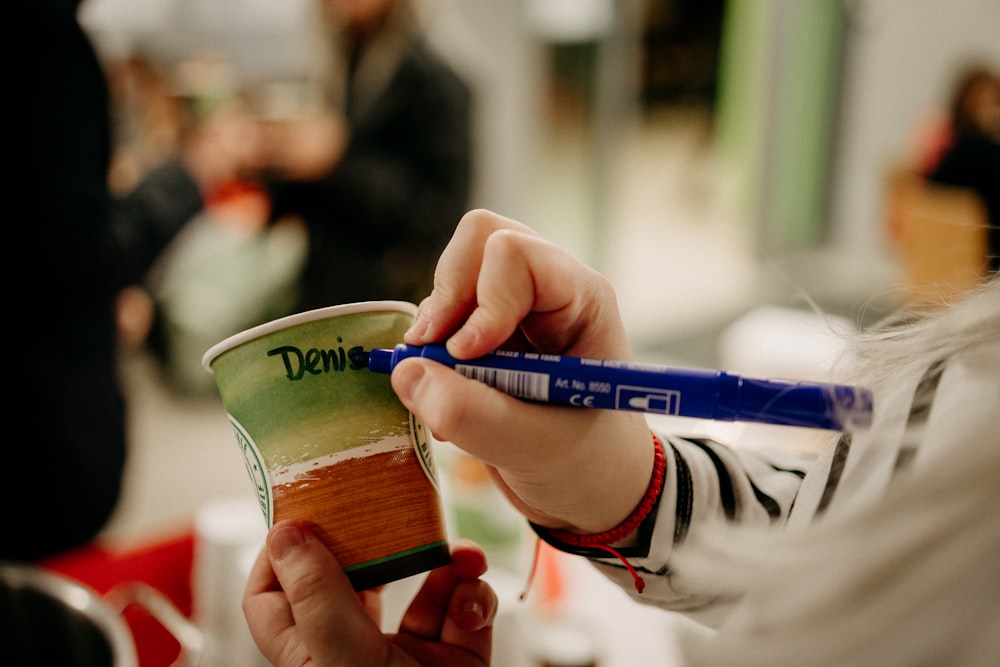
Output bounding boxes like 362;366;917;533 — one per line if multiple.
924;65;1000;272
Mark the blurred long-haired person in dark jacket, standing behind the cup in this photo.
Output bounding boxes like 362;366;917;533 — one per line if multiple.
259;0;472;310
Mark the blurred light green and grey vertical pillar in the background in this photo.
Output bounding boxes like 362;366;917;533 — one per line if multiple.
716;0;844;252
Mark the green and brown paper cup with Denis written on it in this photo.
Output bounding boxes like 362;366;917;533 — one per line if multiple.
202;301;449;590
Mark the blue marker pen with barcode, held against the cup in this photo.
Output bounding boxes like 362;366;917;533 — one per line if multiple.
368;345;873;430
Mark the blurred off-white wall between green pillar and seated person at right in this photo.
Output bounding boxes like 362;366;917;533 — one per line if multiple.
831;0;1000;255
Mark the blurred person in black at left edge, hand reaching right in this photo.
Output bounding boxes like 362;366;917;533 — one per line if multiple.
8;0;254;560
